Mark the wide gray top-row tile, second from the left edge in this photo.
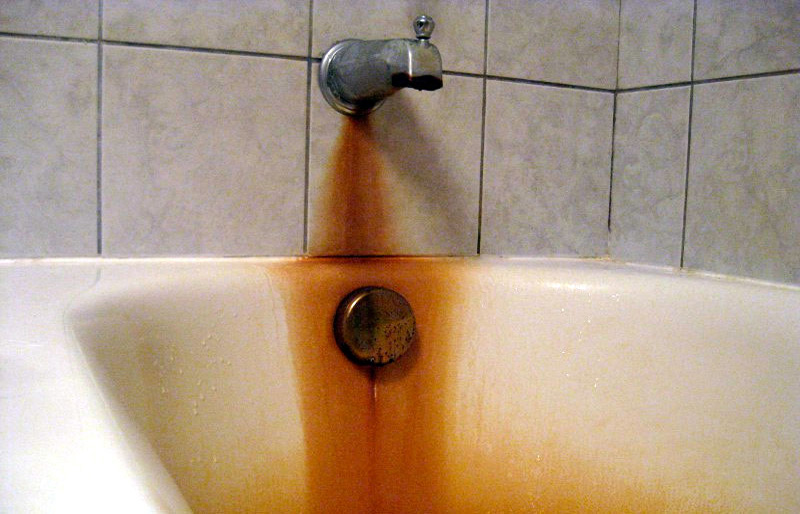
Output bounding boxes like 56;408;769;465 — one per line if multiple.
108;0;309;55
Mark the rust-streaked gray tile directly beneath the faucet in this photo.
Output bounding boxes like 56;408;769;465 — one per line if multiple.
308;67;482;254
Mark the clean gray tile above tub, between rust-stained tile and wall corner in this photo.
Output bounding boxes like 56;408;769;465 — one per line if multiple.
481;81;613;256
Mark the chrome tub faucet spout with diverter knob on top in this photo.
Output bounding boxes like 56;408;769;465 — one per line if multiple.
319;15;442;116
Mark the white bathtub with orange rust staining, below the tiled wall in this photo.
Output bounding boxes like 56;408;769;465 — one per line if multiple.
0;257;800;512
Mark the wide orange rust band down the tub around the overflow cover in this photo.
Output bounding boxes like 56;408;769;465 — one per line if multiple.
274;258;459;513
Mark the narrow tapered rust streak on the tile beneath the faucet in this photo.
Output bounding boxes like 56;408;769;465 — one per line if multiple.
312;117;395;255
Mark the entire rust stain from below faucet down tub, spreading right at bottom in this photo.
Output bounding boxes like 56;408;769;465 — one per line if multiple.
270;114;722;513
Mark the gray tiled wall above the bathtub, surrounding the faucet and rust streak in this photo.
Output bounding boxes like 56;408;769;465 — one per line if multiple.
0;0;800;283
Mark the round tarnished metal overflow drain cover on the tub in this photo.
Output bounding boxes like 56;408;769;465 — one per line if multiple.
333;287;416;366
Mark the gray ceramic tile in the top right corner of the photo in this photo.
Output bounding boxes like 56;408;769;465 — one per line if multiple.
694;0;800;79
